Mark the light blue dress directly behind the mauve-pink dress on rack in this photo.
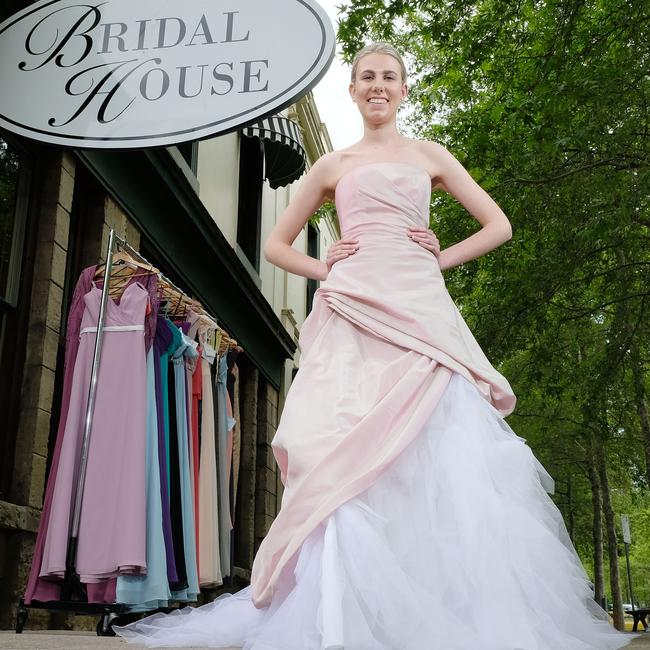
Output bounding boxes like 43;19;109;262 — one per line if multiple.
116;348;171;611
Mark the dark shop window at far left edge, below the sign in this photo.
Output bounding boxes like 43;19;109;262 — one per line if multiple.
0;134;31;500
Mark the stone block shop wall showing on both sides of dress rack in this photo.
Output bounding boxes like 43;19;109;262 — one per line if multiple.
0;152;281;629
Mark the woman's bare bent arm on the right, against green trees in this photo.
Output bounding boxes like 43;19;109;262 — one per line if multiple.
427;142;512;271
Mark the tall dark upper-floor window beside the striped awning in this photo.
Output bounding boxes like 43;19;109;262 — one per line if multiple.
237;136;264;274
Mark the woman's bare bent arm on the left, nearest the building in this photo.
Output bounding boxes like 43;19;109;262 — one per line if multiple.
263;154;330;280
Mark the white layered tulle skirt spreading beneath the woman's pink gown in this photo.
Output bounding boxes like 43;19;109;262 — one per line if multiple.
115;374;631;650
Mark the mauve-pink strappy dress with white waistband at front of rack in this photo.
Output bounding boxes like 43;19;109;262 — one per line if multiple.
40;282;149;583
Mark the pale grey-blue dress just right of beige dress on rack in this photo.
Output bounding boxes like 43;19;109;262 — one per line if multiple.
216;354;235;577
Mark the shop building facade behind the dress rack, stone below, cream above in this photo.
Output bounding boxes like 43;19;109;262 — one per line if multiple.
0;81;340;628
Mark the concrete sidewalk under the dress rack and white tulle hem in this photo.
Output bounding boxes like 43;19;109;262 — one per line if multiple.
0;631;650;650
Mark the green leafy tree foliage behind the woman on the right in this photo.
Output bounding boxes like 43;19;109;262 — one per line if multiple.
338;0;650;603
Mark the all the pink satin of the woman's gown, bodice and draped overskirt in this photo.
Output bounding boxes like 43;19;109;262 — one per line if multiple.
251;162;516;607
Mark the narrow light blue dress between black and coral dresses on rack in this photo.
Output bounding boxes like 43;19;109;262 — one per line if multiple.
172;328;200;601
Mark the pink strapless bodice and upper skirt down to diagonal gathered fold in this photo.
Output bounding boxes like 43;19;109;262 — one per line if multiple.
320;162;515;414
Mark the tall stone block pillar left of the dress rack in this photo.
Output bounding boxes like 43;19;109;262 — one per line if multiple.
0;152;75;628
